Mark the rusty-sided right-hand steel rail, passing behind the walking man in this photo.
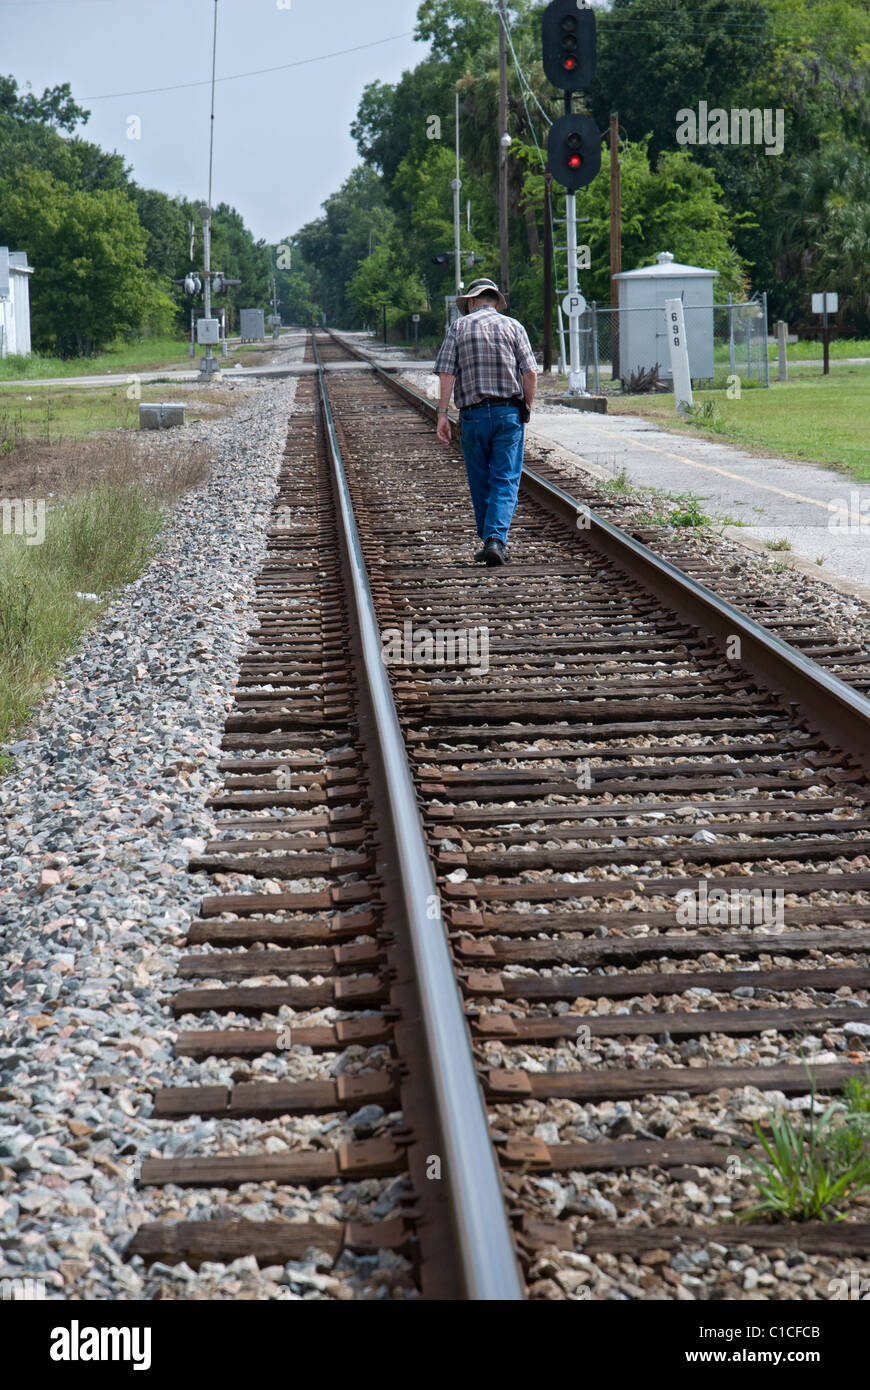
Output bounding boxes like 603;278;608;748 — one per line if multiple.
327;329;870;773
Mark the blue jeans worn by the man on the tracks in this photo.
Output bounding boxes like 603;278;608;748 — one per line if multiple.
461;406;525;543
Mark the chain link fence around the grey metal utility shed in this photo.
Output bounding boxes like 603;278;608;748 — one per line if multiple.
569;293;770;395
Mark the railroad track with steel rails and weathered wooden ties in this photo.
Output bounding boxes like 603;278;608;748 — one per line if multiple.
131;335;870;1300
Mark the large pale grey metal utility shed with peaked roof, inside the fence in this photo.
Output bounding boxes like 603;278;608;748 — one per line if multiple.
605;252;719;379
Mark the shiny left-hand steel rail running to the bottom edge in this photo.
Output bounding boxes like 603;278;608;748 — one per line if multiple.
311;334;525;1302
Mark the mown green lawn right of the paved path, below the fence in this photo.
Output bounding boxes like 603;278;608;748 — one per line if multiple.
607;367;870;482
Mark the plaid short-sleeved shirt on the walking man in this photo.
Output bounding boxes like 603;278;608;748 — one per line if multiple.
435;306;536;410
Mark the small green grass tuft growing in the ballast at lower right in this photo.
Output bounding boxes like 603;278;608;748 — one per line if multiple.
742;1073;870;1220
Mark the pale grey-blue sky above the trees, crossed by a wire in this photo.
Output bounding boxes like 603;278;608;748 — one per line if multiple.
6;0;427;243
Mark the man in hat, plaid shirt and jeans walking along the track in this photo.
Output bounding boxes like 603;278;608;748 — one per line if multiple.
435;279;538;564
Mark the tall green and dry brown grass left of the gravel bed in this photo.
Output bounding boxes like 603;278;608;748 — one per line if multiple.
0;434;207;750
